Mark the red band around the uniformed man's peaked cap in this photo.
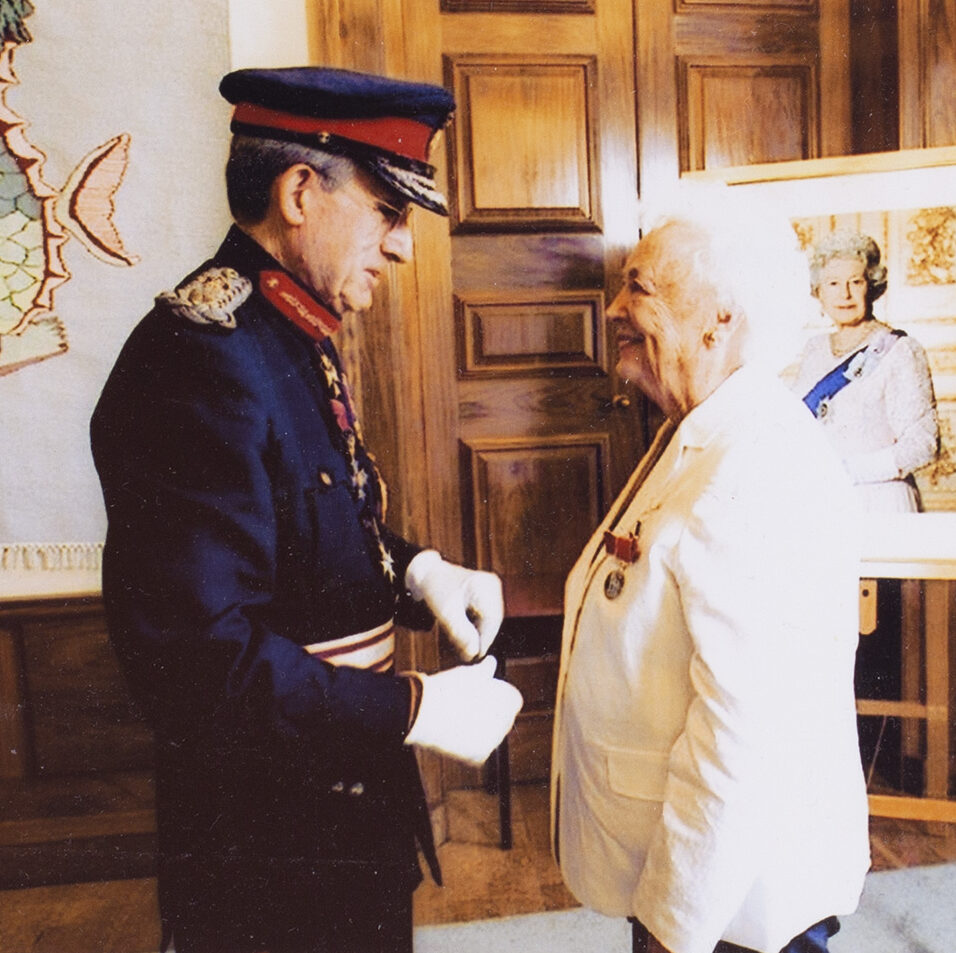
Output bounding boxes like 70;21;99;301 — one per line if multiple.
233;103;434;162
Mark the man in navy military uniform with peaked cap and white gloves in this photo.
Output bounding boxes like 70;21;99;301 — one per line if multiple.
91;68;521;953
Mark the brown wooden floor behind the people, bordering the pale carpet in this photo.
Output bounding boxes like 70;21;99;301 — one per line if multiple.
0;784;956;953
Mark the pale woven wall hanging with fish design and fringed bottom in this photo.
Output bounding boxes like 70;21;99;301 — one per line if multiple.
0;0;231;598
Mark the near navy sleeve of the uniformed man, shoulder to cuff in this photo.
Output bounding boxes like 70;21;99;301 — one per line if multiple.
91;320;410;744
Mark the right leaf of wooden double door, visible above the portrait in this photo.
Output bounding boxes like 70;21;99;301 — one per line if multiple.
636;0;850;193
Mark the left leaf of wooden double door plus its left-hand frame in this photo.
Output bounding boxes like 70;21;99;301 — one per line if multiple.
310;0;648;785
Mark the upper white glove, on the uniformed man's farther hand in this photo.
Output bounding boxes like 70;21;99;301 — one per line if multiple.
405;549;505;662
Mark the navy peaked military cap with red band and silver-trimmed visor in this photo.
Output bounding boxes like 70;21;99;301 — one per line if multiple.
219;66;455;215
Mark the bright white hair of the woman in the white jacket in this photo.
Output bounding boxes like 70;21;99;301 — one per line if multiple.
641;179;817;370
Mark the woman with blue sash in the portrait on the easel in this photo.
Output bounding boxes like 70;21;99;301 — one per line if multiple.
794;229;939;512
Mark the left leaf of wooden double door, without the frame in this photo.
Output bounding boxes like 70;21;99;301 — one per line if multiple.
441;7;647;783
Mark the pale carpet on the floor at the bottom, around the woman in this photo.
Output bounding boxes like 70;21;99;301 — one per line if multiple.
415;864;956;953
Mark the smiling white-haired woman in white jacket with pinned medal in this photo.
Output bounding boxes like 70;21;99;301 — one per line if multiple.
552;195;869;953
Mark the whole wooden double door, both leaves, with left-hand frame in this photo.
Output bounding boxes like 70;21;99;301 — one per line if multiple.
309;0;850;785
